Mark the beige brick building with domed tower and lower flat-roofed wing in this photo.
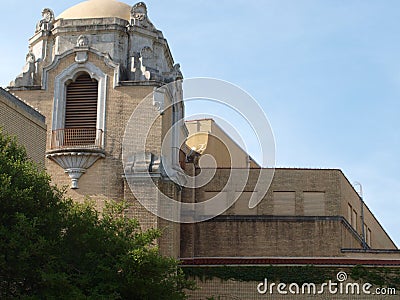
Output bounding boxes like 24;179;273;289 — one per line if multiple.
6;0;400;299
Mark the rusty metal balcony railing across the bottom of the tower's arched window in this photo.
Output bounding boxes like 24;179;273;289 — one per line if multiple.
50;128;103;149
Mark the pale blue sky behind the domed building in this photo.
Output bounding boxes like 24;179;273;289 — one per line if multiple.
0;0;400;245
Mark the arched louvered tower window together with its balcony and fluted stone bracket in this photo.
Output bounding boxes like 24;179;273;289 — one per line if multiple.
47;60;109;189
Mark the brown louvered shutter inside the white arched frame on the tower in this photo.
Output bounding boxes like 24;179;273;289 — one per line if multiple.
65;73;98;146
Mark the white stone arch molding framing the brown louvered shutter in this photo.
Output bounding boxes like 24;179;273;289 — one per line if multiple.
52;62;107;147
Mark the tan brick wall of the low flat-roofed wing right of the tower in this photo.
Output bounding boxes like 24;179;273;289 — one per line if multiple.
181;169;395;257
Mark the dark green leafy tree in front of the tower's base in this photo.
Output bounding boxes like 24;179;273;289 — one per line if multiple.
0;132;193;299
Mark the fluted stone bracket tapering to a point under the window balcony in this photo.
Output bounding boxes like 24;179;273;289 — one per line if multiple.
46;152;105;189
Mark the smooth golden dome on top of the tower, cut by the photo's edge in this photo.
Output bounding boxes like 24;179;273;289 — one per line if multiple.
57;0;131;21
